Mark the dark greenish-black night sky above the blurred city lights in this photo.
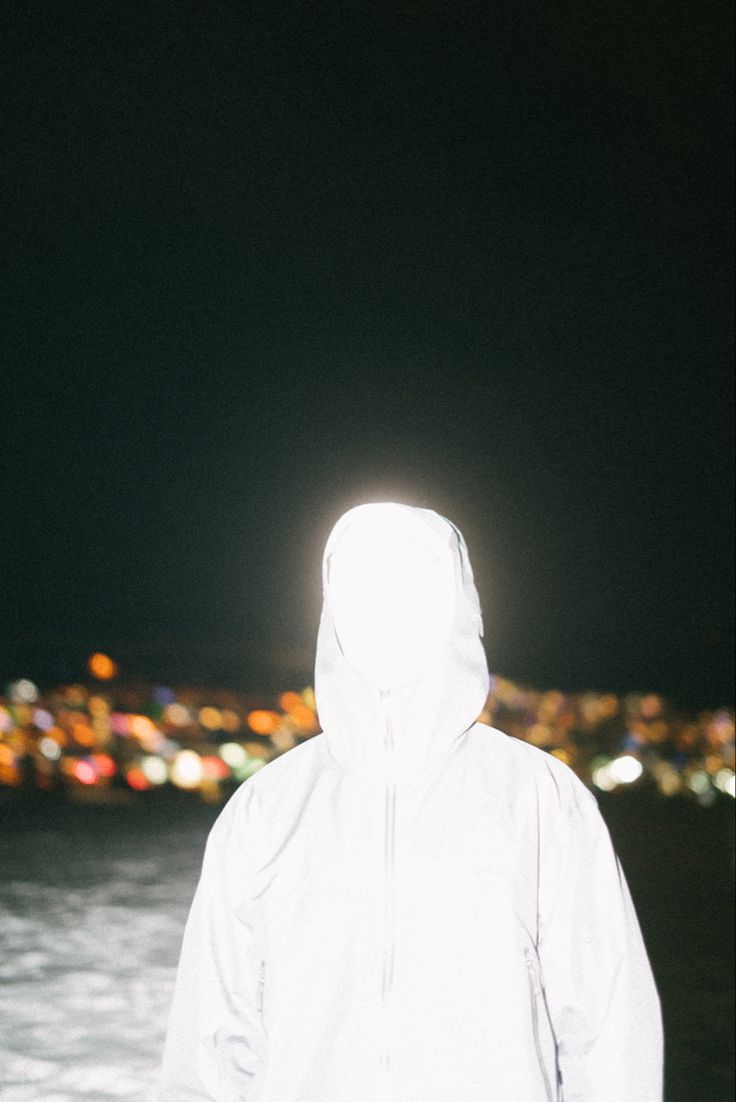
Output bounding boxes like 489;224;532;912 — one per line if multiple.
0;0;733;706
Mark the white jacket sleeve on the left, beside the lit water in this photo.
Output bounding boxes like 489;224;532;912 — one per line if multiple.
156;782;260;1102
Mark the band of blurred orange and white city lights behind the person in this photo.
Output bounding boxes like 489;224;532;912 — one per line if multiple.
0;676;736;807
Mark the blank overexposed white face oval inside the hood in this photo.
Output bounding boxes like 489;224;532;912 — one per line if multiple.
328;505;455;688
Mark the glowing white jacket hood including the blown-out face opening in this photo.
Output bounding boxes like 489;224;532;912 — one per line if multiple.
315;501;490;785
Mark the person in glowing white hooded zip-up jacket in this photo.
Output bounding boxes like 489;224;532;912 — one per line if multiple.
158;503;662;1102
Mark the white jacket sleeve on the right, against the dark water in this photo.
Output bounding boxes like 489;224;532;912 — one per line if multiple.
539;773;663;1102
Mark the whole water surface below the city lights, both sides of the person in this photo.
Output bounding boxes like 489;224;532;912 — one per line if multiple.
0;791;735;1102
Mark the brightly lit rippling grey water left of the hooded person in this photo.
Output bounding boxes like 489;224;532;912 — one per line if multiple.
0;802;217;1102
